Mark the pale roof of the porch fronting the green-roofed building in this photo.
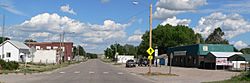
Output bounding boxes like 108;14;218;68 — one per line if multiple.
210;52;242;57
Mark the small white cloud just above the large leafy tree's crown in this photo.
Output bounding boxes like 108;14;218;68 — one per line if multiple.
161;16;191;26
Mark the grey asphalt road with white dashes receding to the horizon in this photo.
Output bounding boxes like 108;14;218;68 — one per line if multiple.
0;59;152;83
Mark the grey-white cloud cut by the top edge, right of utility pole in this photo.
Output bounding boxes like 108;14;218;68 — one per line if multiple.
153;0;207;19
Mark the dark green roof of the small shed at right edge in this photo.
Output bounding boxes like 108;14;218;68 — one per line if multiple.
228;54;250;61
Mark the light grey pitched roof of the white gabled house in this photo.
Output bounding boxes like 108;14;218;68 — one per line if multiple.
1;40;30;49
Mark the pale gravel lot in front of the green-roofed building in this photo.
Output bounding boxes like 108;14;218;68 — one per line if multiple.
114;64;239;83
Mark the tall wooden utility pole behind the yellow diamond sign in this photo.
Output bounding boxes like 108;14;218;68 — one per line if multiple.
148;3;152;74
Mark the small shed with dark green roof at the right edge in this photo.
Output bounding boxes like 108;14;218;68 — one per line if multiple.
228;54;250;70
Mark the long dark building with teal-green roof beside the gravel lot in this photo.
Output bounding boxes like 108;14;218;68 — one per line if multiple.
166;44;235;68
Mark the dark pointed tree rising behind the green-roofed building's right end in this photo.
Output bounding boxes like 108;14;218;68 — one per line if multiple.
205;27;229;44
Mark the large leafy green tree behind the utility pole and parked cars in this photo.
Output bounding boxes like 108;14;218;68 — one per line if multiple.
138;24;200;56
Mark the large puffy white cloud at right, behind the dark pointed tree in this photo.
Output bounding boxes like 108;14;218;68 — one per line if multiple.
194;12;250;39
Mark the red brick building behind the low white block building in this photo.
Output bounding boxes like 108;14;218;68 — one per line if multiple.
26;42;73;61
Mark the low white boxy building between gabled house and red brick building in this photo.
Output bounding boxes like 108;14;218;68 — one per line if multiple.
33;50;57;63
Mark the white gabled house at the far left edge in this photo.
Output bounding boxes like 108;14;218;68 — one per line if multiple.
0;40;31;62
